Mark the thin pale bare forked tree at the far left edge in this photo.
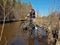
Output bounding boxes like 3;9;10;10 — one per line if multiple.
0;0;14;41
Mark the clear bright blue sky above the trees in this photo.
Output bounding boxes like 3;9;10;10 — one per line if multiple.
21;0;60;16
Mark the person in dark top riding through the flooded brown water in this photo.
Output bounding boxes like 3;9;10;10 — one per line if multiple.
25;9;36;36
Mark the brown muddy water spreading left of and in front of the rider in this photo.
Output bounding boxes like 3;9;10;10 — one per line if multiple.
0;22;47;45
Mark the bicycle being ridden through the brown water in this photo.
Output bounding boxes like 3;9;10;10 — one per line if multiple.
21;19;35;38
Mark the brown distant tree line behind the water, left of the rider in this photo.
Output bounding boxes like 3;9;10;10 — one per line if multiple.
0;0;32;20
